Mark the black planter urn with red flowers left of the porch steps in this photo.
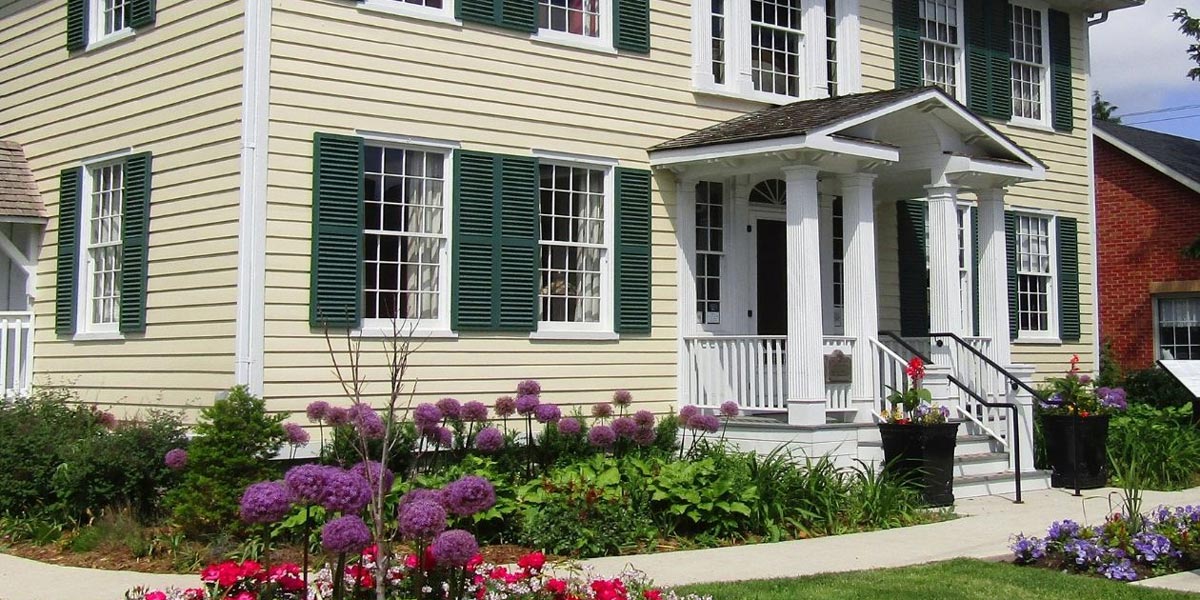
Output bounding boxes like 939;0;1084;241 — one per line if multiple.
880;422;959;506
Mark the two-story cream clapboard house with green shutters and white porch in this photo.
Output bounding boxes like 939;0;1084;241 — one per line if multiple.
0;0;1136;492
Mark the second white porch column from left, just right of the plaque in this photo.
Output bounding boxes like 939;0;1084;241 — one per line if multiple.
839;174;880;421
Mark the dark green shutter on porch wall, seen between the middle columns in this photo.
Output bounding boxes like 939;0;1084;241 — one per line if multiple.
896;200;929;337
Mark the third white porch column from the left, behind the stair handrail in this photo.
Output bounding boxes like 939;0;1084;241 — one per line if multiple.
925;185;964;365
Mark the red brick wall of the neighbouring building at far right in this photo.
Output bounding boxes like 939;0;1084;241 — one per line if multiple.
1096;138;1200;368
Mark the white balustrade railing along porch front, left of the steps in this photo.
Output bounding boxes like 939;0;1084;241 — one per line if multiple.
680;336;854;412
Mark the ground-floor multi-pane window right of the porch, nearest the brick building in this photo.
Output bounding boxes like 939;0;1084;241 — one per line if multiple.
1016;215;1055;335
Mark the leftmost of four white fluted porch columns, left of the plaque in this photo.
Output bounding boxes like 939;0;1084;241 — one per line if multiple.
780;166;826;425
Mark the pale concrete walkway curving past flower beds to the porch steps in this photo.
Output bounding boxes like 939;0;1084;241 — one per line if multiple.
0;487;1200;600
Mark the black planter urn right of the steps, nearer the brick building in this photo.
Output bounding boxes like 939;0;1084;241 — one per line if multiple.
1042;414;1109;490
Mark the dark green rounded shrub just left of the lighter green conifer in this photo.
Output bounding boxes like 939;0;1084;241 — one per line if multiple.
52;412;187;520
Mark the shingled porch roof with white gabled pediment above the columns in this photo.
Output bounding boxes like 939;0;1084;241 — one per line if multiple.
649;86;1045;185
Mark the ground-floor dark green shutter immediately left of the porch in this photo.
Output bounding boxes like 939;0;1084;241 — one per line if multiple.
614;168;650;334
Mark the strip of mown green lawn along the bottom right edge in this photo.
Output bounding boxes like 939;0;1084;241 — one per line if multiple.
680;559;1200;600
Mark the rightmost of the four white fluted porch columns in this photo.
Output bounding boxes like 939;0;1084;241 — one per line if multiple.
976;188;1013;366
